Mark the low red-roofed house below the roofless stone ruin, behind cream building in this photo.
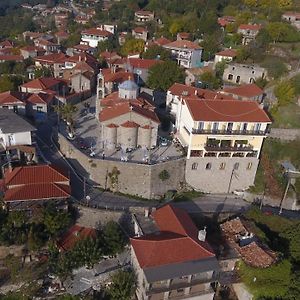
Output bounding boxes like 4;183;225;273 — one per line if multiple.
221;83;264;103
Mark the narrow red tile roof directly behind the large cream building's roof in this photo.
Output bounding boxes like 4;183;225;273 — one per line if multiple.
168;83;233;100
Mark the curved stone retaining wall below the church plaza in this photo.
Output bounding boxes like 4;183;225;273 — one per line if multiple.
58;134;185;199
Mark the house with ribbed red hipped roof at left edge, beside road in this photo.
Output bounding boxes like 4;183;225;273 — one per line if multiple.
3;165;71;212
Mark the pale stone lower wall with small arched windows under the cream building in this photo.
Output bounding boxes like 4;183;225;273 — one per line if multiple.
185;157;259;193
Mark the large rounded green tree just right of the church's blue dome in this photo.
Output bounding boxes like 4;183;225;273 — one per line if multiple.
147;61;185;91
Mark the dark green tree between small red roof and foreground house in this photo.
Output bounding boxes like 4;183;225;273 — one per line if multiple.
103;221;126;254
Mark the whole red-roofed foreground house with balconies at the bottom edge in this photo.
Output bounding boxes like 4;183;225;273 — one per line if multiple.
130;204;219;300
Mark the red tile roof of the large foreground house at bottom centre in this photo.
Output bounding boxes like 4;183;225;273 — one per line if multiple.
131;205;215;268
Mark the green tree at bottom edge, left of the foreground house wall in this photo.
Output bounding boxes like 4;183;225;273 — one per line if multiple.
108;271;136;300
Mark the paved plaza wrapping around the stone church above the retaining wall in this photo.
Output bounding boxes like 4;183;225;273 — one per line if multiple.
61;99;184;164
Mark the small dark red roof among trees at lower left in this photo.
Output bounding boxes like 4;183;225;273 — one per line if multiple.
57;225;97;251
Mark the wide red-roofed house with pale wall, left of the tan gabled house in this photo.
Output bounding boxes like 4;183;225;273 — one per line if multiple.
20;77;68;95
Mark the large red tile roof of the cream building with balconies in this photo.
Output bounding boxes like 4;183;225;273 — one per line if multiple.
184;98;271;123
